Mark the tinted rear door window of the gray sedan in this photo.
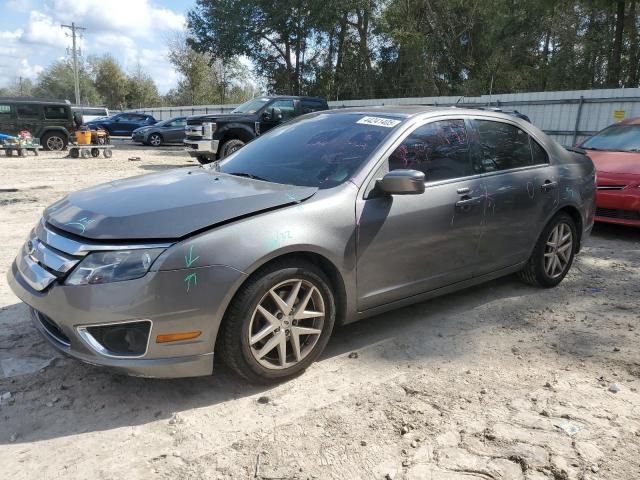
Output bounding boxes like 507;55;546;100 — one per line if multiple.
475;120;532;172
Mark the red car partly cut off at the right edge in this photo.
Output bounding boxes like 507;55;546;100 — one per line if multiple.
580;117;640;227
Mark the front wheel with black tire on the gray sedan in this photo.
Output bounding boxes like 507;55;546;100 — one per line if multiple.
216;260;335;384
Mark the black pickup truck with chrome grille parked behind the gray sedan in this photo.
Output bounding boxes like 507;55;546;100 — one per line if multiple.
184;96;329;163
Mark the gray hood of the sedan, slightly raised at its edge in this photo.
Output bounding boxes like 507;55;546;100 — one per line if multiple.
44;167;317;240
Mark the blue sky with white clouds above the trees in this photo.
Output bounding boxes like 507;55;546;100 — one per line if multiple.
0;0;195;94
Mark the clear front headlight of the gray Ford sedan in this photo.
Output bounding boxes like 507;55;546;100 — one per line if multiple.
65;248;165;285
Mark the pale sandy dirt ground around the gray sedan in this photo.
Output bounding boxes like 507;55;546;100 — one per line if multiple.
0;141;640;480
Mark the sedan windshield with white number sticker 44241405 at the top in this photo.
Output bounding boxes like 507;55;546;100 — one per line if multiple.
218;113;401;188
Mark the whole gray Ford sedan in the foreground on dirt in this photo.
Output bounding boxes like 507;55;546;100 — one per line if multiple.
8;107;595;382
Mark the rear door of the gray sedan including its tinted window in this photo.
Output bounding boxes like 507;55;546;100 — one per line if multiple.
471;118;558;275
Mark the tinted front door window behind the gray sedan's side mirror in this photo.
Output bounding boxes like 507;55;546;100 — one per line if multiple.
389;120;474;182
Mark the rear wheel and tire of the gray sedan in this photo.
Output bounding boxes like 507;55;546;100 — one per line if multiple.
518;213;578;288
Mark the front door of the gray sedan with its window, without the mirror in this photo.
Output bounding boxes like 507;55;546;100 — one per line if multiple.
356;118;485;311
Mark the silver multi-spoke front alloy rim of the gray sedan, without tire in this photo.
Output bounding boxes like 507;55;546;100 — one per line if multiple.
247;278;325;370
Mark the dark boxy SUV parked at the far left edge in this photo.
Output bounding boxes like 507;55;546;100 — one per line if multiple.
0;97;82;150
